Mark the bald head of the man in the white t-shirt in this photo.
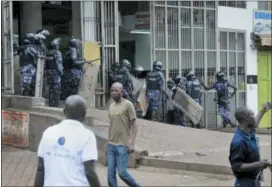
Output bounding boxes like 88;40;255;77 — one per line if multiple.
64;95;87;121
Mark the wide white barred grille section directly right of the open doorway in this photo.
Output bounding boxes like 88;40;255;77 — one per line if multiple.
151;1;217;124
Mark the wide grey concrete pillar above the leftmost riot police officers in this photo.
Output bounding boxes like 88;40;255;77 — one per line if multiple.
22;1;42;34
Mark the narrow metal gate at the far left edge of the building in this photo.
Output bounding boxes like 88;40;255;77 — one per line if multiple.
1;1;14;94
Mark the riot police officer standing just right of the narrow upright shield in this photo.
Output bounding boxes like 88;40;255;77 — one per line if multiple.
45;38;63;107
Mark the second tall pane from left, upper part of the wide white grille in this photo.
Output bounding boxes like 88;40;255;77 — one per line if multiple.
168;8;179;49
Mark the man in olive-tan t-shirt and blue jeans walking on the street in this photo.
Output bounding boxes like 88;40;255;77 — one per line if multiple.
107;82;139;187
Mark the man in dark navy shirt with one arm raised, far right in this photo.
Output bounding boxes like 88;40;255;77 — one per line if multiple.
229;103;271;187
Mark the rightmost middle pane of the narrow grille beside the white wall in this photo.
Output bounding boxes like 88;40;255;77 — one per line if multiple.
237;52;245;90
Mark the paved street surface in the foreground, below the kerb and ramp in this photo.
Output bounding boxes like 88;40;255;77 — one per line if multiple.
2;146;271;186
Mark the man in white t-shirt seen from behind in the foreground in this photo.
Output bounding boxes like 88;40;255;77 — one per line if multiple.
35;95;100;187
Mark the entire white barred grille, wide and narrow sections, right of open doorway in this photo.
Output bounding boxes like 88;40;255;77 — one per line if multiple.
150;1;245;128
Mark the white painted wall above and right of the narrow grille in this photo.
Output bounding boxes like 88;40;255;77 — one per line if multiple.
218;2;258;112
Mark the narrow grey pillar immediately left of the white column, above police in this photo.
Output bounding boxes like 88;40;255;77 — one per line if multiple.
72;1;81;38
